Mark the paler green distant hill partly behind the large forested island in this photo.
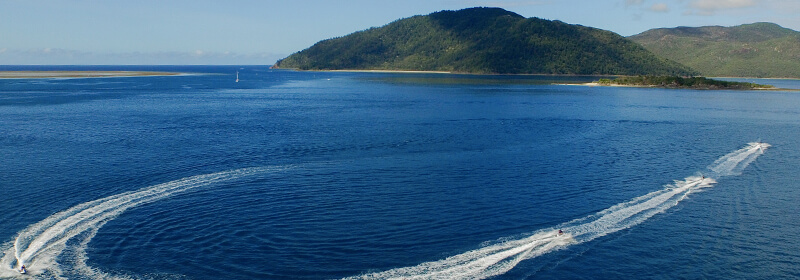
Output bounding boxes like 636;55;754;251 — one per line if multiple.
630;23;800;78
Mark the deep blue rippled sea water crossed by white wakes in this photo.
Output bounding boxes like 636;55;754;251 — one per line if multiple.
0;66;800;279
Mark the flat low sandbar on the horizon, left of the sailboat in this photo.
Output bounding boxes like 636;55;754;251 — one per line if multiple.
0;70;185;79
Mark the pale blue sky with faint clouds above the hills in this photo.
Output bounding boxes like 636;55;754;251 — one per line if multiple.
0;0;800;65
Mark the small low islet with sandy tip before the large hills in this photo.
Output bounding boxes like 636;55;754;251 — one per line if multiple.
597;75;773;89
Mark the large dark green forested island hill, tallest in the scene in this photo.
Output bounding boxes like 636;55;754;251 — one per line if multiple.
275;8;694;75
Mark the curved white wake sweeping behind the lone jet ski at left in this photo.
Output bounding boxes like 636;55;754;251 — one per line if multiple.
0;167;287;278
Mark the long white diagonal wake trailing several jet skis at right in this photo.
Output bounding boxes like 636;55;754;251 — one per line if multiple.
345;142;770;279
